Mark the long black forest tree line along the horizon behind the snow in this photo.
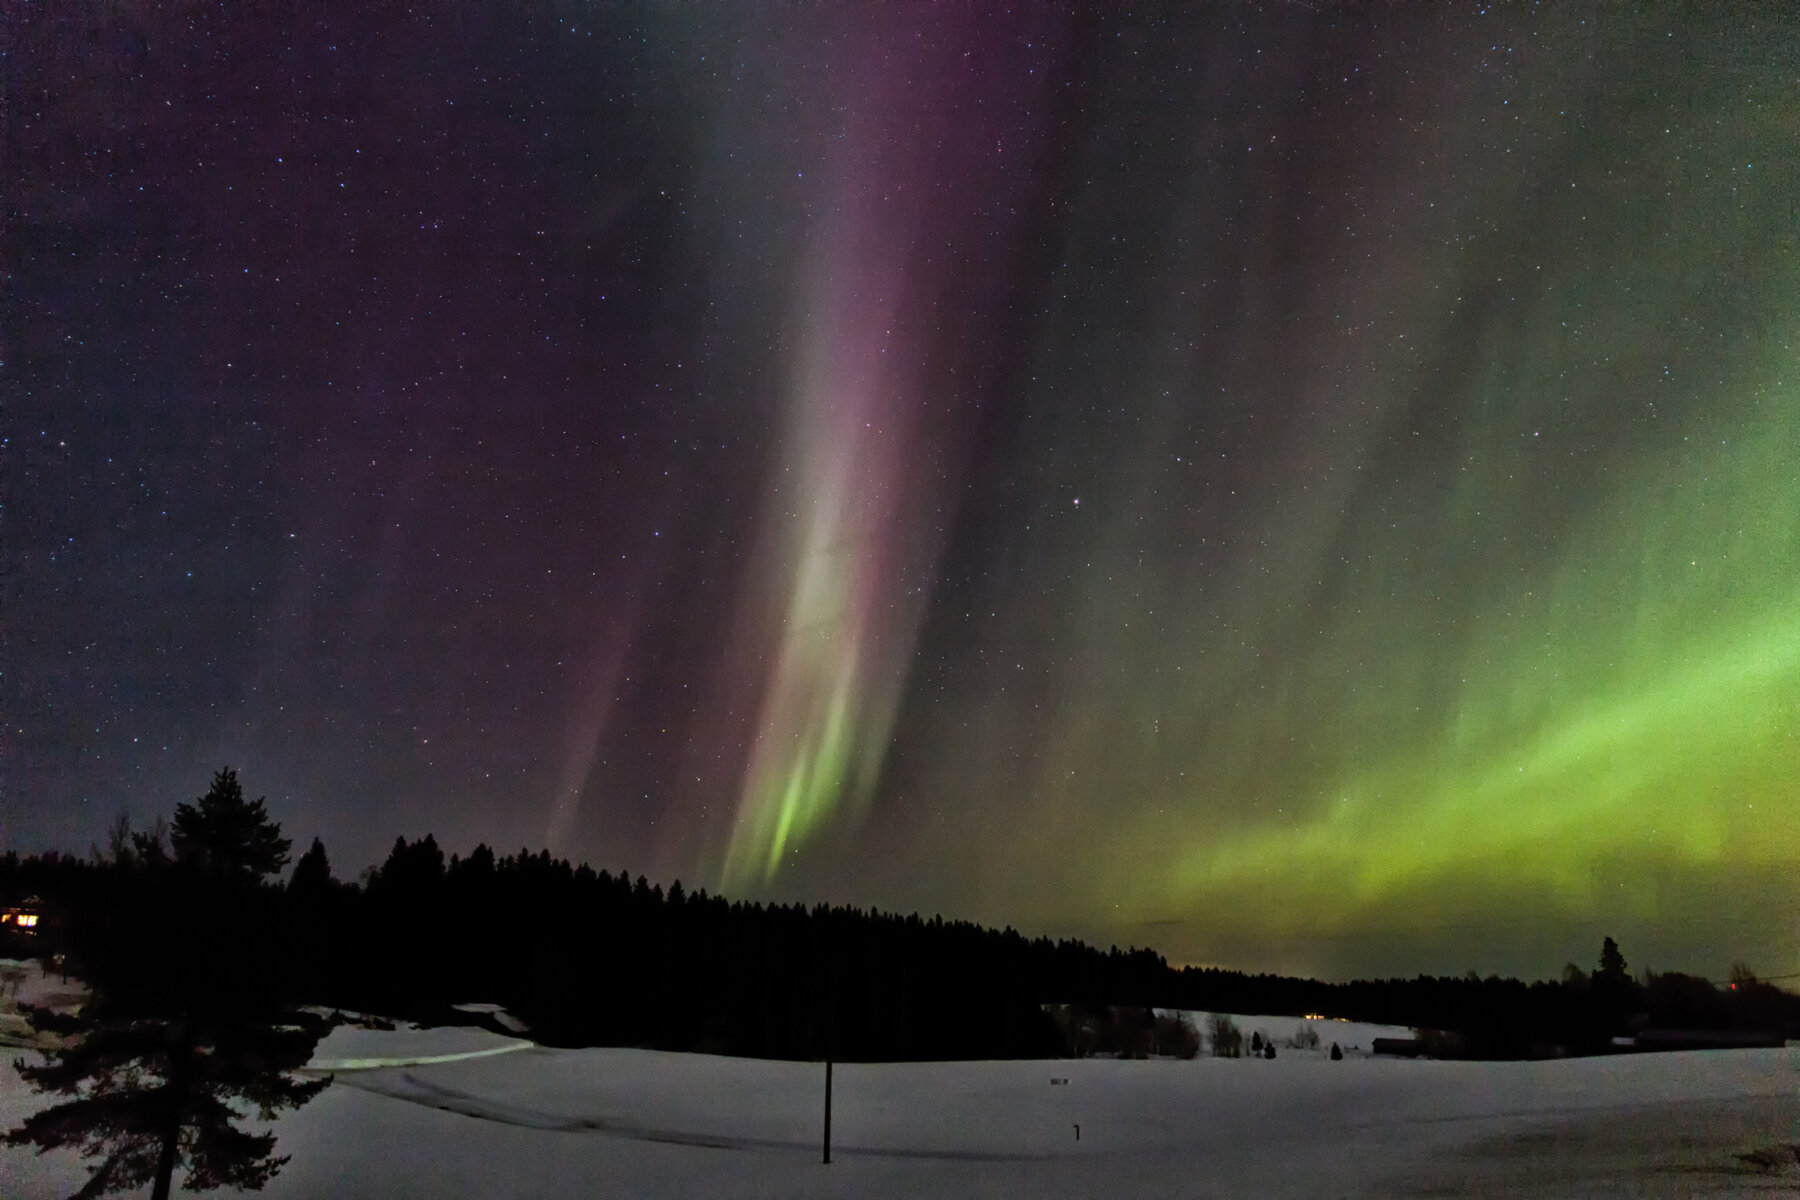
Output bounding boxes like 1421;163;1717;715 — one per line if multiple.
0;820;1800;1060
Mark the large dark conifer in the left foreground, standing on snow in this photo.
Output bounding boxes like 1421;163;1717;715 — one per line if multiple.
5;770;329;1200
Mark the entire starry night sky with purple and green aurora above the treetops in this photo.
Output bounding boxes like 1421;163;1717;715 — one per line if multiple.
0;0;1800;977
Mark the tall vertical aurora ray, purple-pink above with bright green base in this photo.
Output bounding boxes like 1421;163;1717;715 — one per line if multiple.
724;5;1042;887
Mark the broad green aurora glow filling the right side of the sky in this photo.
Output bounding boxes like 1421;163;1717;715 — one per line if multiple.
738;11;1800;973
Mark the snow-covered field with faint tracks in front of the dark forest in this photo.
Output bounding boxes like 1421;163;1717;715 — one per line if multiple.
0;964;1800;1200
